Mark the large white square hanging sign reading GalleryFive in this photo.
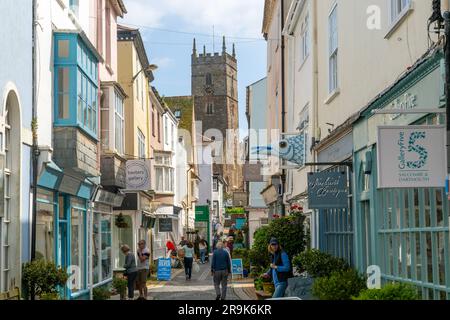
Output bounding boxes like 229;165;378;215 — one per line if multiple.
377;126;447;189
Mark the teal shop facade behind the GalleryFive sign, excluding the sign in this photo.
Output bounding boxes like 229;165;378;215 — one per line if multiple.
352;49;450;300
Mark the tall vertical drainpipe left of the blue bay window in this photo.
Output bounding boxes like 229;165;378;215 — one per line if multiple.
31;0;40;261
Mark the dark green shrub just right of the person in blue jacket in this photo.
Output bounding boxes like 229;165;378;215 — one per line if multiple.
292;249;350;278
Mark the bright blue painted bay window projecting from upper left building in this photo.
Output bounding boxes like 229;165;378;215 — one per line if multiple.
54;33;99;140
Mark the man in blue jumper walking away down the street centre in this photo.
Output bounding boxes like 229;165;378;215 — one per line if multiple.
211;242;231;300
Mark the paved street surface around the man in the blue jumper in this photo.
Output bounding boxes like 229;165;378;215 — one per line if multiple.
148;263;239;300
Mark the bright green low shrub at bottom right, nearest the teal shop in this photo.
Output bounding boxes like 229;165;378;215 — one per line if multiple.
353;283;419;300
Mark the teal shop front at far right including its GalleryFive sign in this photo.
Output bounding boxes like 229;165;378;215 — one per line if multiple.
353;50;450;300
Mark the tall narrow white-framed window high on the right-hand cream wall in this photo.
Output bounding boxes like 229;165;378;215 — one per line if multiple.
328;4;338;93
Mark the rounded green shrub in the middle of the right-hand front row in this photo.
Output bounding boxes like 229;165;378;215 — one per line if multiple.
312;269;366;300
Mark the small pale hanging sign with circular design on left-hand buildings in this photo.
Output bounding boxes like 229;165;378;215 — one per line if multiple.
126;160;152;191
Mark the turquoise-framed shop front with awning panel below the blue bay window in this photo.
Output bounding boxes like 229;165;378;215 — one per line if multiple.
36;163;95;299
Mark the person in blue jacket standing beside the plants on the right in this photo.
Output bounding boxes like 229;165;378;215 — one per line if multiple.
264;238;292;298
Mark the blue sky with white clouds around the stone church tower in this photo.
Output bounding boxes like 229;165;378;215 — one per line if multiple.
119;0;267;136
